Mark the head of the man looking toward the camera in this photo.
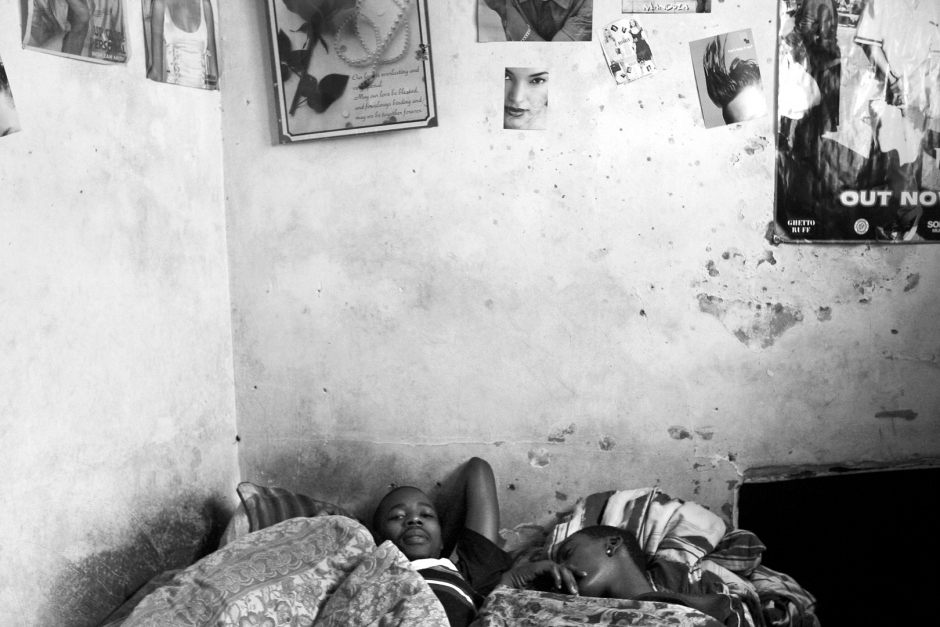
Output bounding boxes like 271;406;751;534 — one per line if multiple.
372;486;443;560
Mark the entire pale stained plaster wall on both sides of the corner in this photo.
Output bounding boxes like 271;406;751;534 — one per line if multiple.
0;0;940;627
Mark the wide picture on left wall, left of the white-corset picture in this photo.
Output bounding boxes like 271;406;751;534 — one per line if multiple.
23;0;127;63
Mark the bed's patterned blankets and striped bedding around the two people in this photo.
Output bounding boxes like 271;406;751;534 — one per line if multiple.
101;482;819;627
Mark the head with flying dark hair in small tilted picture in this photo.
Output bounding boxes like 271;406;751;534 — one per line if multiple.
702;35;767;124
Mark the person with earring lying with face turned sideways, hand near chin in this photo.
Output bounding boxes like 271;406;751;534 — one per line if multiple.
500;526;751;627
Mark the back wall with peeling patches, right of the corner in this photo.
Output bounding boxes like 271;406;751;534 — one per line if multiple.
223;0;940;527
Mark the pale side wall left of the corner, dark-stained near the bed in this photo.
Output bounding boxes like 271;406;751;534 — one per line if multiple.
0;0;238;627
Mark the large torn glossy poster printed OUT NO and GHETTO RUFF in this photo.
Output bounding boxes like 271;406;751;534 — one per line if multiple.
775;0;940;243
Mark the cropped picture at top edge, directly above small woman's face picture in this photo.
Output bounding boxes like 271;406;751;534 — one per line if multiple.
477;0;594;42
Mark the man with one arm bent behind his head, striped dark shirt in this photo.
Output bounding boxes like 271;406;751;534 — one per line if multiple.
373;457;512;627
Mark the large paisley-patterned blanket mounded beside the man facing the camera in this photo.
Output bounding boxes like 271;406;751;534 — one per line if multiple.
106;516;448;627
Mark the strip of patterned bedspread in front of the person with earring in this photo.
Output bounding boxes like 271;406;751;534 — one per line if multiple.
471;586;721;627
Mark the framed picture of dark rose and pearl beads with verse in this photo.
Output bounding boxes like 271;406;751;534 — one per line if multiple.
267;0;437;143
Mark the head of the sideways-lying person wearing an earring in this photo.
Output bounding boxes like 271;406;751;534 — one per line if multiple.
556;525;647;599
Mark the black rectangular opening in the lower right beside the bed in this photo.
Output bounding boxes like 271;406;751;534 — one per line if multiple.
738;468;940;627
